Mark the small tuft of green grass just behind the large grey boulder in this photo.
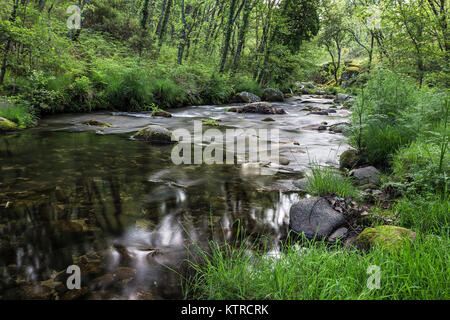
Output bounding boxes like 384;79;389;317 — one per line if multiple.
306;166;357;198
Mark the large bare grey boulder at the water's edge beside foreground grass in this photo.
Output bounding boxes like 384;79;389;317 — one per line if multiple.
289;197;346;240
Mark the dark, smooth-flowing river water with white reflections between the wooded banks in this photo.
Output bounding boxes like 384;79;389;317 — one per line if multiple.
0;96;349;299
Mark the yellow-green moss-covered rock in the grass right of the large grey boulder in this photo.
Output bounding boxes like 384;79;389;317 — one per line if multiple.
355;226;416;250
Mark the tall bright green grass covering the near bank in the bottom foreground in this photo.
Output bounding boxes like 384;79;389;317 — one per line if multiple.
185;230;450;300
